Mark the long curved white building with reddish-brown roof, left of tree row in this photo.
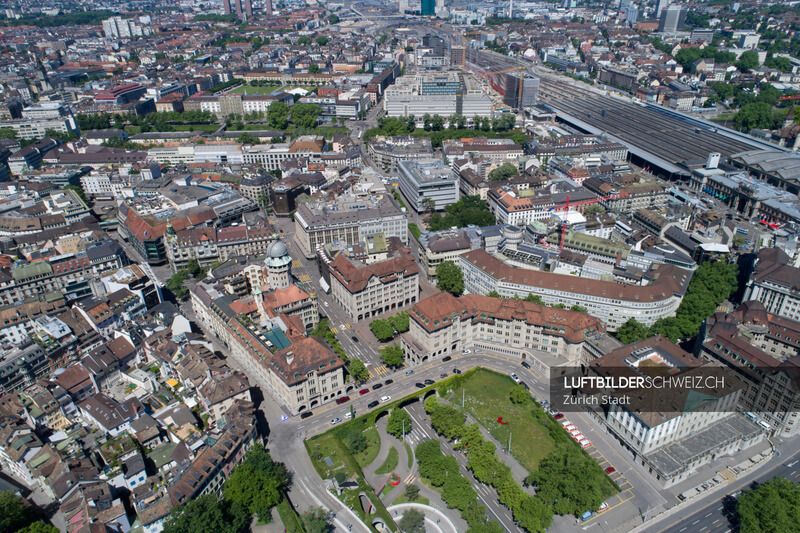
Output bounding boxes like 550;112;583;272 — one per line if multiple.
456;250;691;331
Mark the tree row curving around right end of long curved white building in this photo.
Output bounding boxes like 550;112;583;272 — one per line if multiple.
616;260;739;344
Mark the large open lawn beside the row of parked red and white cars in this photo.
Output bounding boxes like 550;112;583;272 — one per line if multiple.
450;369;555;472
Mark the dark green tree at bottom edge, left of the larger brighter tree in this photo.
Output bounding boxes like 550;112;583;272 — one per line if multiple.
163;494;250;533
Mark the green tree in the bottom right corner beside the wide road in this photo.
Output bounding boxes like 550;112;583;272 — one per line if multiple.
736;477;800;533
